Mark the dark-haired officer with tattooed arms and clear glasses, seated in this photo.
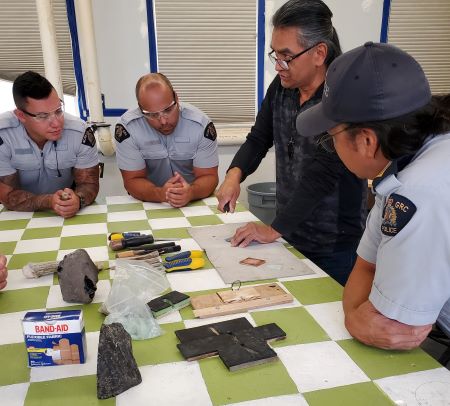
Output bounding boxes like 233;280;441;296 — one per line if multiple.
0;71;99;218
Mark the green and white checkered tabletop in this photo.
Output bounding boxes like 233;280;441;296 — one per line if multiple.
0;196;450;406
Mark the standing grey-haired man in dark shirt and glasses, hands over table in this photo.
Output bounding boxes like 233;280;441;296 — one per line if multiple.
217;0;367;284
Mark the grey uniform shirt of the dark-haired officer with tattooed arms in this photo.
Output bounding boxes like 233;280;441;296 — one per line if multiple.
0;112;98;194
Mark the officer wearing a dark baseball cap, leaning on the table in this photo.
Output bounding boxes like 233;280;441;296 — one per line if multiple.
297;42;450;349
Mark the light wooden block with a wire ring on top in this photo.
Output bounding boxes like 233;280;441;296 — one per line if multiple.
191;283;294;318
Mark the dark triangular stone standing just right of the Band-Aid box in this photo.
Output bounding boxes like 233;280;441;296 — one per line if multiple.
97;323;142;399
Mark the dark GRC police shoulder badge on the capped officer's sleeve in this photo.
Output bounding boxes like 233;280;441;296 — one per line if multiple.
381;193;417;237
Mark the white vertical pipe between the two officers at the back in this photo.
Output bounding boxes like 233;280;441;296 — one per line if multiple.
73;0;114;156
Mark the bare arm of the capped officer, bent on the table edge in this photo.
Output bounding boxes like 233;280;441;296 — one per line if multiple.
343;257;431;350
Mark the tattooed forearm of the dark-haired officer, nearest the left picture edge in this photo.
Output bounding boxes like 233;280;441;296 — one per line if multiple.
0;172;52;211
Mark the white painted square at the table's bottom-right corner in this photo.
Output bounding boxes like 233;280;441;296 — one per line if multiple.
374;368;450;406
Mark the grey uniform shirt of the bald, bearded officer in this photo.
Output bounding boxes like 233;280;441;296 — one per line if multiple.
116;103;219;187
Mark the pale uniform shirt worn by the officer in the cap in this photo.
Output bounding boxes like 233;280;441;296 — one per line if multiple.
357;134;450;334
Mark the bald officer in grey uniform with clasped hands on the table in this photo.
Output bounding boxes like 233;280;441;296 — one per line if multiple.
115;73;219;207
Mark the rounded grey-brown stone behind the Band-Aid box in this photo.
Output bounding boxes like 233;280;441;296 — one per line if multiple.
58;250;98;303
